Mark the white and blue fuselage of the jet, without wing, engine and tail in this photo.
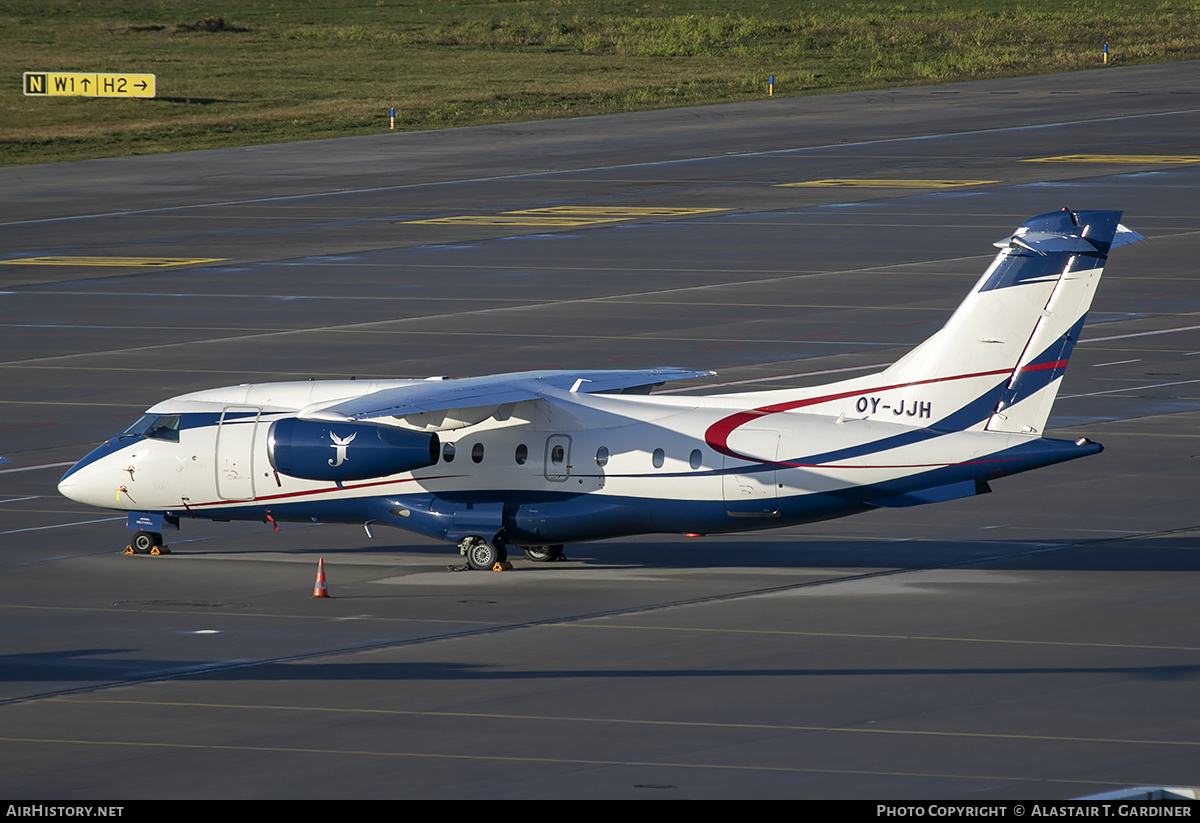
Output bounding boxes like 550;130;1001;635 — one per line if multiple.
61;382;1099;545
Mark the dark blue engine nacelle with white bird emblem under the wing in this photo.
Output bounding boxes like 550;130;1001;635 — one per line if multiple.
266;417;442;481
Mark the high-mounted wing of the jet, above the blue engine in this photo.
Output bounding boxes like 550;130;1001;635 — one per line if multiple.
299;368;713;422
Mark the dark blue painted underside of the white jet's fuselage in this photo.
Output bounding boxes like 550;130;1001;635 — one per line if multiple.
157;439;1102;545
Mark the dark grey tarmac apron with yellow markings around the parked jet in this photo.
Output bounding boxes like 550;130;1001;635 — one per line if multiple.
0;62;1200;799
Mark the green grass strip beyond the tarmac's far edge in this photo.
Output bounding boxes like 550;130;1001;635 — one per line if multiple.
0;0;1200;166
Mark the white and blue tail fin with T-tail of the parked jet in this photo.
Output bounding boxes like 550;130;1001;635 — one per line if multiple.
875;209;1144;434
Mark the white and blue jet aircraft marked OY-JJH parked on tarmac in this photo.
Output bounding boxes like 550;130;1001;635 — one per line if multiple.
59;209;1142;569
